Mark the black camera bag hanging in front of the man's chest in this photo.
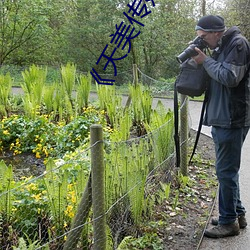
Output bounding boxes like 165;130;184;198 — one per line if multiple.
175;58;209;97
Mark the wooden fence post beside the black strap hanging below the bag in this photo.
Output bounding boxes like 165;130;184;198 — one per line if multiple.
180;94;188;176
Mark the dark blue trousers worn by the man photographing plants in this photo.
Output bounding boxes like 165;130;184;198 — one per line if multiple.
212;127;249;224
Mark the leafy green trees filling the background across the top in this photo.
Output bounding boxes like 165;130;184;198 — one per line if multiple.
0;0;230;79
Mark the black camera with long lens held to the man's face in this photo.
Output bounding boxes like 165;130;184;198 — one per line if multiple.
176;36;208;63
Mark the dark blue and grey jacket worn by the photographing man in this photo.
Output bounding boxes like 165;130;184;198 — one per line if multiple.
203;27;250;128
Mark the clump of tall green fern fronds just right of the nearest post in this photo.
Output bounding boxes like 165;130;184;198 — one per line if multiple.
105;139;151;225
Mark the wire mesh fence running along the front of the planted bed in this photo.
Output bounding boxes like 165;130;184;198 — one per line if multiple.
0;64;190;250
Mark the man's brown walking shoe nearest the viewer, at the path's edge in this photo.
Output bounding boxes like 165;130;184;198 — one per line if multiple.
204;222;240;238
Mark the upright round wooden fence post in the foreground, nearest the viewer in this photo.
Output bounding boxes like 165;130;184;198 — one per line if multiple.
90;124;106;250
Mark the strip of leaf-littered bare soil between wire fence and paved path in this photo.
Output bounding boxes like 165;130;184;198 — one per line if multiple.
158;131;218;250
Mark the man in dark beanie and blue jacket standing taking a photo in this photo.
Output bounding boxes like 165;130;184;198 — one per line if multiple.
193;15;250;238
